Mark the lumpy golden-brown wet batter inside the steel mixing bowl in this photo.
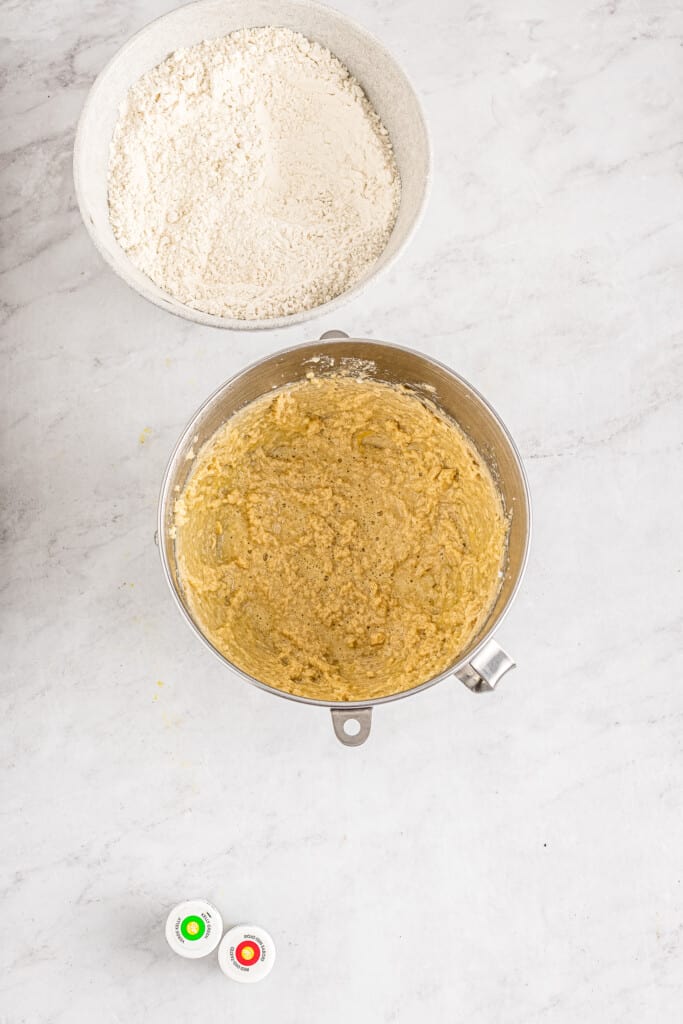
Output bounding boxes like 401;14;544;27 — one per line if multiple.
175;377;508;701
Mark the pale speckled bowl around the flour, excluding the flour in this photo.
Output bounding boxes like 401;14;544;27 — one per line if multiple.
74;0;430;331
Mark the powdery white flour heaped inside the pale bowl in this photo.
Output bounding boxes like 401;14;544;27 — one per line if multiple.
109;28;400;319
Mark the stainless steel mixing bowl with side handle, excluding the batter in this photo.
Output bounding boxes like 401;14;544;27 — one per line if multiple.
158;331;531;746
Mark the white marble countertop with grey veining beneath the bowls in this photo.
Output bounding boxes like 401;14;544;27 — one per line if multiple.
0;0;683;1024
